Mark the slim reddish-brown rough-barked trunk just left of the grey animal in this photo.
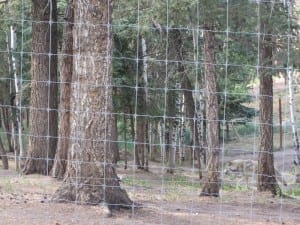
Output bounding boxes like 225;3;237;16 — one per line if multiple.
200;24;220;197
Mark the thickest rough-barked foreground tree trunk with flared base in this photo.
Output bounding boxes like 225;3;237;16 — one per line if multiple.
53;0;132;207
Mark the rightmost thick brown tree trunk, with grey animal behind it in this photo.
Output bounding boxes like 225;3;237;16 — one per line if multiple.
257;14;279;195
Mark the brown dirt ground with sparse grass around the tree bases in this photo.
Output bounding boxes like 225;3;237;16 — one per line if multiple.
0;149;300;225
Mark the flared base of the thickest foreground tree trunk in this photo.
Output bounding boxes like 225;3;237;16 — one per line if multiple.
52;178;134;210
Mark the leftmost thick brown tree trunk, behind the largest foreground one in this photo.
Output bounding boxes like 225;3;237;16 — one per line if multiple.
23;0;57;174
